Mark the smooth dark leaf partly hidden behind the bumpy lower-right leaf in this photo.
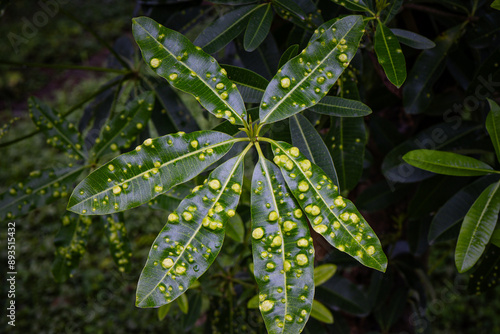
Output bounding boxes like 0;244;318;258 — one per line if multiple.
290;114;338;184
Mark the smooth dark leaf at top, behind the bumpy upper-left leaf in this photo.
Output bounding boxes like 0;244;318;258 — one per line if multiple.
194;4;265;53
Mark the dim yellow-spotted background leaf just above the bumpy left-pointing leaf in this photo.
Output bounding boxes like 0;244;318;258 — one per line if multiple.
92;92;154;157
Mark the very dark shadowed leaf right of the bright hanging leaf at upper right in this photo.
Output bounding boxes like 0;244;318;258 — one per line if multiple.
403;26;461;114
